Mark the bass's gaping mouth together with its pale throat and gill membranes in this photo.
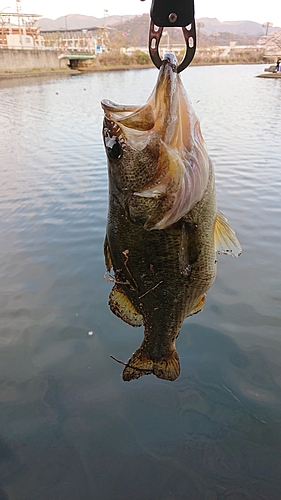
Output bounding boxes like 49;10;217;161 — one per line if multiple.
101;53;210;229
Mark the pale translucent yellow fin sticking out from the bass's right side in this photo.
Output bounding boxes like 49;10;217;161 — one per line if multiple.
214;211;242;257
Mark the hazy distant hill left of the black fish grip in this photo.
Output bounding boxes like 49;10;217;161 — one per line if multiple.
38;14;135;31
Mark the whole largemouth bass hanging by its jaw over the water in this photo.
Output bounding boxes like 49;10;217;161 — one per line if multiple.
102;54;241;381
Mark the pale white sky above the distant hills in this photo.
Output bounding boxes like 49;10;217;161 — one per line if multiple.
0;0;281;27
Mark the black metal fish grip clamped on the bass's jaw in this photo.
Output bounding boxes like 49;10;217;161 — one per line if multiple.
149;0;196;73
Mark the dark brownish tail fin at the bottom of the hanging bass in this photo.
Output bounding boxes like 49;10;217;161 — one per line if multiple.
122;347;180;382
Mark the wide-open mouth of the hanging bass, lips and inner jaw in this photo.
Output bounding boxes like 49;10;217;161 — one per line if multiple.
101;53;195;150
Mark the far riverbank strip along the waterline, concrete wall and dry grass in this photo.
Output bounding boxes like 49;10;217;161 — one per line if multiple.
0;47;270;79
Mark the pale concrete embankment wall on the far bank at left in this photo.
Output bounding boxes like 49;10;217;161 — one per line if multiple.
0;49;68;72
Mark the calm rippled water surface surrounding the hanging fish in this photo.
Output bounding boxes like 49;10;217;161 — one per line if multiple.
0;66;281;500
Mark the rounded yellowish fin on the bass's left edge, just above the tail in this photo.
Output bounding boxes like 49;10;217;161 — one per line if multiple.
109;285;143;327
